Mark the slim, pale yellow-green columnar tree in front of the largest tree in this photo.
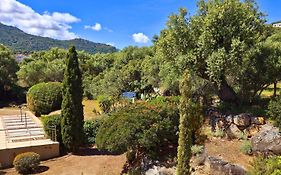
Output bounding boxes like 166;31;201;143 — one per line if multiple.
177;72;201;175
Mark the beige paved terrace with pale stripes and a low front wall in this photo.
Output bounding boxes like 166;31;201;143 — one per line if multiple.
0;109;59;168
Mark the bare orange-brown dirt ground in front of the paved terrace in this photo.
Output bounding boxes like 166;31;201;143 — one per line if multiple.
0;148;126;175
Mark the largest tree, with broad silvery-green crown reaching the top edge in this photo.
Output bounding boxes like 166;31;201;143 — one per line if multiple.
156;0;270;103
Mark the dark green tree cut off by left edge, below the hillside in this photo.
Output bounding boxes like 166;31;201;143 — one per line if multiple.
0;44;19;99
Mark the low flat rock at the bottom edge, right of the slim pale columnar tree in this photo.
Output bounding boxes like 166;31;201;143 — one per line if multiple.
203;157;246;175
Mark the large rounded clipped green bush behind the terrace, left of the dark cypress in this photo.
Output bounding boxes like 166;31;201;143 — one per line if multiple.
26;82;62;116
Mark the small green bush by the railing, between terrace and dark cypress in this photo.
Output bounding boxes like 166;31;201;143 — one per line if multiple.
41;114;62;143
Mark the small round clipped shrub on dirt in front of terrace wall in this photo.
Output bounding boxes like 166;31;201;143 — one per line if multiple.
13;152;40;174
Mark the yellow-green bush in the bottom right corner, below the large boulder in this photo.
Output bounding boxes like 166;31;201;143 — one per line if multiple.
248;156;281;175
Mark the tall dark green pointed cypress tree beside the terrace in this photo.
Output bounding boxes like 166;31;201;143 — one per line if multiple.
61;46;84;153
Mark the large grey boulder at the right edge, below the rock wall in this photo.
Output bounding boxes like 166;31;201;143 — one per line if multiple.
251;126;281;155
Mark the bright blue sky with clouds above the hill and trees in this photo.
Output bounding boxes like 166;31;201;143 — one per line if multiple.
0;0;281;48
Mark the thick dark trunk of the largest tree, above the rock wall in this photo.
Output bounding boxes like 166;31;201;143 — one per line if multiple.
218;78;239;105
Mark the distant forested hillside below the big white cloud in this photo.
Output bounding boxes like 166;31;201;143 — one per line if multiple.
0;23;117;53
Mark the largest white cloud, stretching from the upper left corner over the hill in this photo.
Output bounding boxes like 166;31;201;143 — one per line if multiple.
0;0;80;39
